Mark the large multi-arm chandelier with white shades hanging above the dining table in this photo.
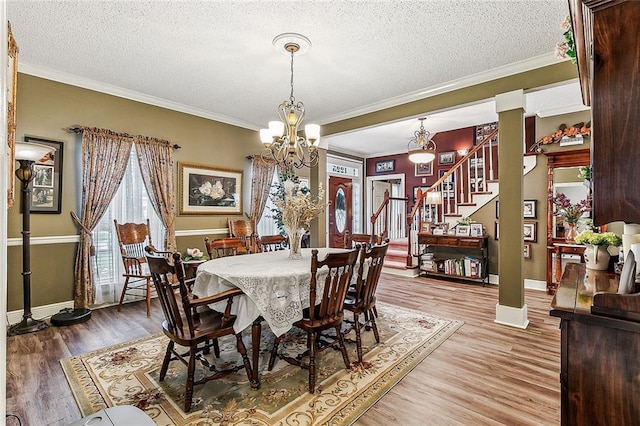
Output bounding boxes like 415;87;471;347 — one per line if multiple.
260;33;320;169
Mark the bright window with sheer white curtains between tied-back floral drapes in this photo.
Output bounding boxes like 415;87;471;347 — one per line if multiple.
91;146;165;305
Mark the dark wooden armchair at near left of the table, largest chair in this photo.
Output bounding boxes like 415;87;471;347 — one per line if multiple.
147;253;252;412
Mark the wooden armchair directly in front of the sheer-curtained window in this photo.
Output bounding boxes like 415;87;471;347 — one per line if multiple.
113;219;167;316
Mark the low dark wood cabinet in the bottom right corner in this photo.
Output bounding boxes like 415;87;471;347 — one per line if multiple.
551;263;640;426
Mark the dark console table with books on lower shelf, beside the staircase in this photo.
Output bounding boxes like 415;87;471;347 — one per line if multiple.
418;233;489;285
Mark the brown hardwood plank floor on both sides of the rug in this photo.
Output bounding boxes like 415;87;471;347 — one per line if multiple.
7;274;560;426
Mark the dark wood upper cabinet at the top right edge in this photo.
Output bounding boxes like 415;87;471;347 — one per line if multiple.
569;0;640;226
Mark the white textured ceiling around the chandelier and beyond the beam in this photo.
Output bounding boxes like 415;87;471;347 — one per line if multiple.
7;0;580;156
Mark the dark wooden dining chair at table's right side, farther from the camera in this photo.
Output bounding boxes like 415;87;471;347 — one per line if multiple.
344;244;389;364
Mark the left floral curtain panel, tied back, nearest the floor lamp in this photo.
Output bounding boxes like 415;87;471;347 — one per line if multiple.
74;127;133;309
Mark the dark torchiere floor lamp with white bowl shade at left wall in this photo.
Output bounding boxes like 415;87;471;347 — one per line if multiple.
7;142;55;336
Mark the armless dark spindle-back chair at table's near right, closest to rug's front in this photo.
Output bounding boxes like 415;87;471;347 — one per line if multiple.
268;249;358;393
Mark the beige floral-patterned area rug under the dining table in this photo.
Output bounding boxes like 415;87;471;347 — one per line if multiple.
60;303;463;426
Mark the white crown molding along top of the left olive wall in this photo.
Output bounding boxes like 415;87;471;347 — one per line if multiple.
18;62;259;131
